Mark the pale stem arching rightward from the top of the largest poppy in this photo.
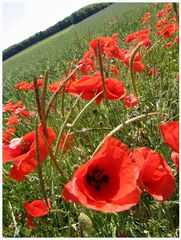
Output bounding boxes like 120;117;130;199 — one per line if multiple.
92;112;160;157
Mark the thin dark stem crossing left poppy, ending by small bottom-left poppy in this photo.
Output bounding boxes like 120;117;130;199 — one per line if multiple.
35;118;48;206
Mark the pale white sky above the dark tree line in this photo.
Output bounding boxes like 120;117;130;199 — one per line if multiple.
1;0;113;50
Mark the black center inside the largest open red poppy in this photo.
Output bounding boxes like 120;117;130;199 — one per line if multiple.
86;168;109;191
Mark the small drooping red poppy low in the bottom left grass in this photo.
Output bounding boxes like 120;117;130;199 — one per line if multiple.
23;200;50;228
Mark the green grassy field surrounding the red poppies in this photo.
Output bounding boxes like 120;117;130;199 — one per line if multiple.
3;3;179;238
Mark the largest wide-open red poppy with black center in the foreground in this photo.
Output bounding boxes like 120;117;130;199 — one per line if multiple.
63;137;141;213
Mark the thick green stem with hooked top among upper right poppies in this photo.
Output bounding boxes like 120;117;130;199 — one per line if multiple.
129;42;142;97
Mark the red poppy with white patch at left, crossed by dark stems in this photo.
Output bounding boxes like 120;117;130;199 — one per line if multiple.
3;126;55;181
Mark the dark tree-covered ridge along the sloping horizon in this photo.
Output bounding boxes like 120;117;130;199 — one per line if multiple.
3;3;113;61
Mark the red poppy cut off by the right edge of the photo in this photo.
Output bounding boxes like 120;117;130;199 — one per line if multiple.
159;121;179;169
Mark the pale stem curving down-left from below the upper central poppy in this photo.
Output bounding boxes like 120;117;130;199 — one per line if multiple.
60;91;102;159
